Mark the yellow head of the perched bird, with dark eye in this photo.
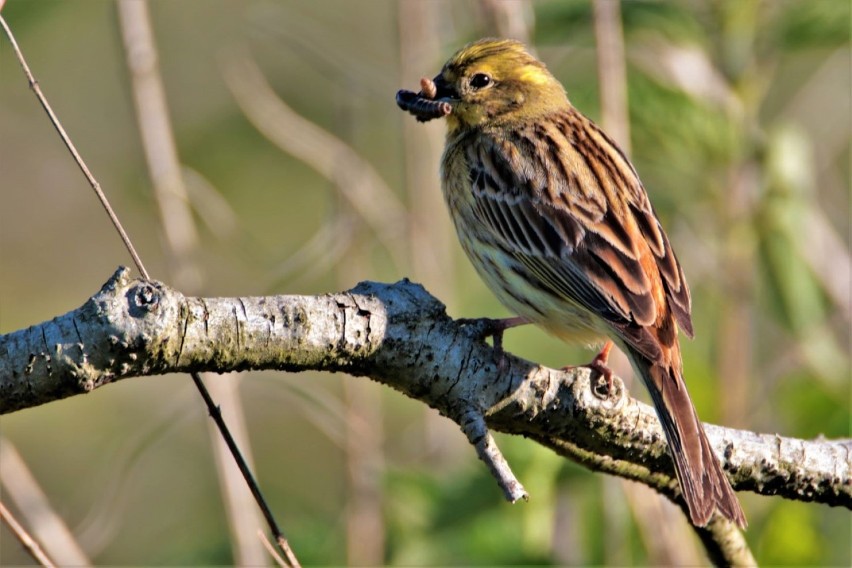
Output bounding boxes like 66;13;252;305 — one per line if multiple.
434;39;568;132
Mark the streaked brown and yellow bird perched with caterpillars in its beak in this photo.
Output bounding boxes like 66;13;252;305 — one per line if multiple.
397;38;746;528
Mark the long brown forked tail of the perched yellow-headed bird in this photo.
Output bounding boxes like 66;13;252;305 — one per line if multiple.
631;352;746;528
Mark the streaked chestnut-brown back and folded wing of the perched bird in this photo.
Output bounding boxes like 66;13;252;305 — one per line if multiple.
467;118;692;360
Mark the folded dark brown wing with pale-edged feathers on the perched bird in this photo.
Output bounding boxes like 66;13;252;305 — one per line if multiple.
468;134;692;361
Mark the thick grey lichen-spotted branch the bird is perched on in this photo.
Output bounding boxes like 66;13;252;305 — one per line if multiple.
0;268;852;516
